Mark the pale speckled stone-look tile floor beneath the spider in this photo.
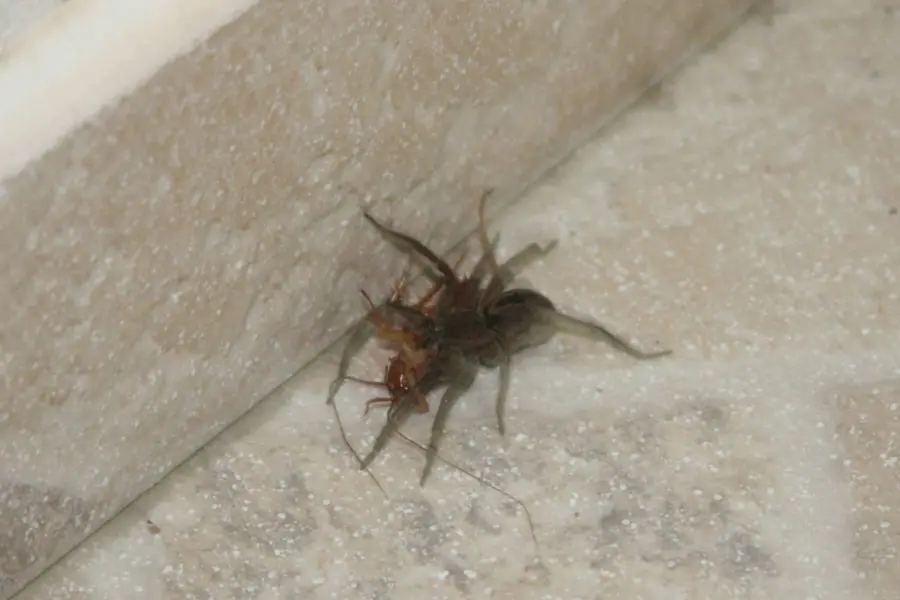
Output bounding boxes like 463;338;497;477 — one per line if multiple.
14;0;900;600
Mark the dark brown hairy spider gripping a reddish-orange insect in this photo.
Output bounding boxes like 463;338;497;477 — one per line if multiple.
329;194;671;485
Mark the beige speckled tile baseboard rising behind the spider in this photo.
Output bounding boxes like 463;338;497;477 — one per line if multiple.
0;0;749;595
